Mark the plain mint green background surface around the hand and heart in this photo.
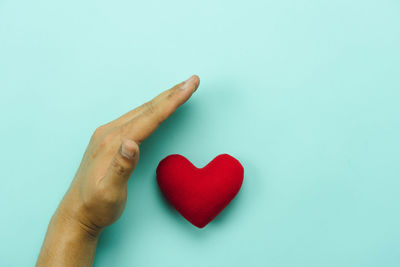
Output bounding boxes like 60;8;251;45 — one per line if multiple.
0;0;400;267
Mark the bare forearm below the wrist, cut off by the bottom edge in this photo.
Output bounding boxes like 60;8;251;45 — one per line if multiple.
36;210;100;266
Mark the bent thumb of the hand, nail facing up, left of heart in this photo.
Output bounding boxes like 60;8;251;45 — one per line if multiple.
103;139;139;185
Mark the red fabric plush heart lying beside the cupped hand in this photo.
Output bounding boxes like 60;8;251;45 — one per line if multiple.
156;154;244;228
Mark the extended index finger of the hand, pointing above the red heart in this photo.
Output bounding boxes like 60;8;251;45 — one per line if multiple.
122;75;200;144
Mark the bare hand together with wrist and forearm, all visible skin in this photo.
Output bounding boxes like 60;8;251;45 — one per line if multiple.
36;75;200;266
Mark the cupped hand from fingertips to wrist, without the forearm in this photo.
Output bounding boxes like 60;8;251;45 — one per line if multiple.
59;76;199;234
